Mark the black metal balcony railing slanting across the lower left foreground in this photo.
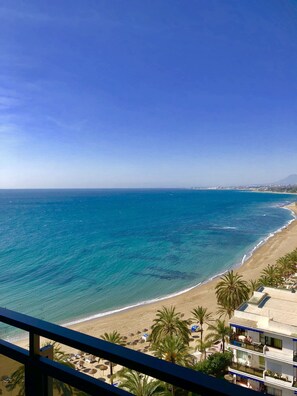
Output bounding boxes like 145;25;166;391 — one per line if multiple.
0;308;257;396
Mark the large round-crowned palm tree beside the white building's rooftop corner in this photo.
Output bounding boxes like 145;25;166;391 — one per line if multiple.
216;270;249;318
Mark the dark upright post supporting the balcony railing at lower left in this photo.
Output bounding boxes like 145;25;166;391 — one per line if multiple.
25;333;53;396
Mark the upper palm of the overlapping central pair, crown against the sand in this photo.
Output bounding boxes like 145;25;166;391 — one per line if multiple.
150;307;190;345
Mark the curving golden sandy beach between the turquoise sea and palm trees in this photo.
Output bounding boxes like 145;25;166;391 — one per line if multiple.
13;203;297;348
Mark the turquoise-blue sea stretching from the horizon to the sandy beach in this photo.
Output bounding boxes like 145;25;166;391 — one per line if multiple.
0;190;296;336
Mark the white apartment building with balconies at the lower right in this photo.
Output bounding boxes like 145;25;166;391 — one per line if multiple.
229;287;297;396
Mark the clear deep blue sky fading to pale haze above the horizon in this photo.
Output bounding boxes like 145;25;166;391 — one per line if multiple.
0;0;297;188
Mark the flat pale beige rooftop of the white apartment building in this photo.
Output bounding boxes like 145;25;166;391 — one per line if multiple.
230;287;297;337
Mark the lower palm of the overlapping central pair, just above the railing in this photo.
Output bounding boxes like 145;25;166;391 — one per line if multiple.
151;335;189;365
